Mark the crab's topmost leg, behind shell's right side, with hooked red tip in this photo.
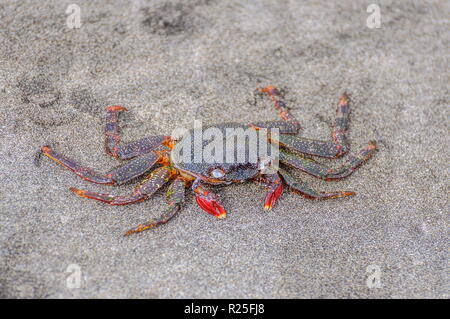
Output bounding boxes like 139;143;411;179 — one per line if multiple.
250;85;300;134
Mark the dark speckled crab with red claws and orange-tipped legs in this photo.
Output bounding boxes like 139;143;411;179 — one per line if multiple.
41;85;377;236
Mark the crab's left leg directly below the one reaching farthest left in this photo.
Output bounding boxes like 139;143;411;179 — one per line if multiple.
70;166;173;205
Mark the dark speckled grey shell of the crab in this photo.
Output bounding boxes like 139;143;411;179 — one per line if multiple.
170;123;276;185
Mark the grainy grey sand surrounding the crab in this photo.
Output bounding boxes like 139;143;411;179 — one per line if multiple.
0;0;450;298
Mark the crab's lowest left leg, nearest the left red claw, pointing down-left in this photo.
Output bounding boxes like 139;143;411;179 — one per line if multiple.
124;177;186;236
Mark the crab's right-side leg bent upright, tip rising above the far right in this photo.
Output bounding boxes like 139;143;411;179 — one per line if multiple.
272;93;356;158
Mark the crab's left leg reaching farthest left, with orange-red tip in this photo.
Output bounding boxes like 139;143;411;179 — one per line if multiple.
42;146;165;185
